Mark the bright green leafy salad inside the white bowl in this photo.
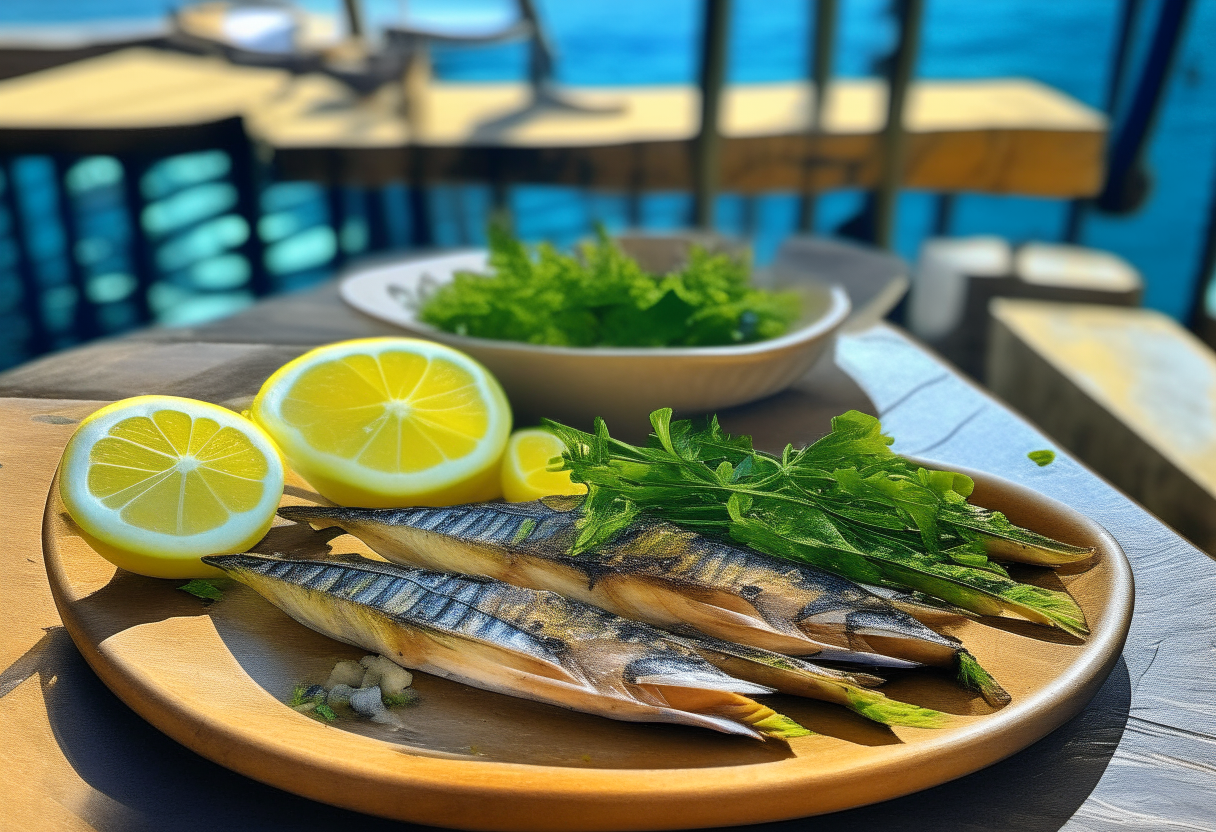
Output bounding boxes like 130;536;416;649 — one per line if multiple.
418;225;799;347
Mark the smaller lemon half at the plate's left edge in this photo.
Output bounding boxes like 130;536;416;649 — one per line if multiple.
60;395;283;578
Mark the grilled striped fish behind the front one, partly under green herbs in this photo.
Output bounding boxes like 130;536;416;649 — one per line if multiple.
278;501;961;667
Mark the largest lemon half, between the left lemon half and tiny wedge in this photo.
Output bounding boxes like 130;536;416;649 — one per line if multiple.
250;338;511;507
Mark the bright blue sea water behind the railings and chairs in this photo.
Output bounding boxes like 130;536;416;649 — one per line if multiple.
0;0;1216;360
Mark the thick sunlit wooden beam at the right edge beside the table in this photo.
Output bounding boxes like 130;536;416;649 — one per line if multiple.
987;299;1216;555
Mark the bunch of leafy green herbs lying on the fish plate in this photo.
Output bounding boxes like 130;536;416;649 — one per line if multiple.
546;409;1092;635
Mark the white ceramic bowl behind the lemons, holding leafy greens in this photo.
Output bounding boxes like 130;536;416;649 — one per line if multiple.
340;251;849;433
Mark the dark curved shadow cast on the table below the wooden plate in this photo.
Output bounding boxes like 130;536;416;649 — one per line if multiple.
0;628;1131;832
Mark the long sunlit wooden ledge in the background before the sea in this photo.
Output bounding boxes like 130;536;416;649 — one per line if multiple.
0;49;1107;197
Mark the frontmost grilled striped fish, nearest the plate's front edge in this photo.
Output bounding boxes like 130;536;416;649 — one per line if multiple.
204;555;807;740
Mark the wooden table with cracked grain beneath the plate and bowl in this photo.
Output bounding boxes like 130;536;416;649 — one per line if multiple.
0;253;1216;832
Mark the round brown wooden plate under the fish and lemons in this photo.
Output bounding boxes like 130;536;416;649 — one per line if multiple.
43;464;1133;830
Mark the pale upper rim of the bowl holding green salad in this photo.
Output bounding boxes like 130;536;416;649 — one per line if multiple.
338;248;852;359
